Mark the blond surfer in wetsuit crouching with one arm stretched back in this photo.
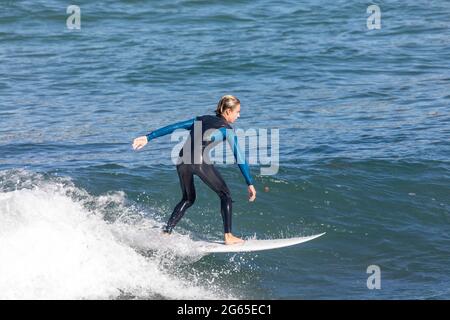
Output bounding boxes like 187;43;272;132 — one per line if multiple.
133;95;256;244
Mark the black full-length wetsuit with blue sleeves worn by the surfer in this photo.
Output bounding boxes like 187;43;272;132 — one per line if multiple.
147;115;253;233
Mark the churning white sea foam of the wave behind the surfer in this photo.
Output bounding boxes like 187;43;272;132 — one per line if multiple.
0;171;231;299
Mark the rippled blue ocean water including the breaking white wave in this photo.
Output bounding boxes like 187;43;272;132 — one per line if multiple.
0;0;450;299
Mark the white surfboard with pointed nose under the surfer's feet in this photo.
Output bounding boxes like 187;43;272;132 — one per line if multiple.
196;232;325;253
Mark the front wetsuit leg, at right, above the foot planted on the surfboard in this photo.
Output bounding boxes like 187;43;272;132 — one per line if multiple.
194;163;232;233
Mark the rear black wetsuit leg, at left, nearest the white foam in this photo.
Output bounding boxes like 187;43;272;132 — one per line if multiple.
164;163;195;233
